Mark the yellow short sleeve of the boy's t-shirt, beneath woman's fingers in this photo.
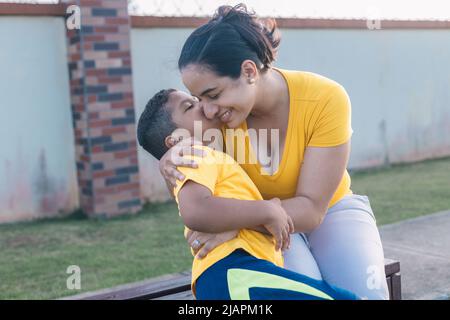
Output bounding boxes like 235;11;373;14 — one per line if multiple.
174;148;219;202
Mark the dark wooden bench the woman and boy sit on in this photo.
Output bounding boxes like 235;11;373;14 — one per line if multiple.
63;259;402;300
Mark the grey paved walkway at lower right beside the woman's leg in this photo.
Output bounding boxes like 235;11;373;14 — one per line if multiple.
380;211;450;300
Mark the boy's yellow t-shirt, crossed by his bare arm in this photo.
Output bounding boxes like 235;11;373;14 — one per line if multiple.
174;146;283;293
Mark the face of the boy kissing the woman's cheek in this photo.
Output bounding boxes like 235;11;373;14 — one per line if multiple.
166;90;222;136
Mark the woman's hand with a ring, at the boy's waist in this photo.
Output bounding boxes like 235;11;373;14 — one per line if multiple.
186;230;239;259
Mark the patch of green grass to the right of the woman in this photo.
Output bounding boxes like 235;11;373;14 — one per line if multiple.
351;158;450;225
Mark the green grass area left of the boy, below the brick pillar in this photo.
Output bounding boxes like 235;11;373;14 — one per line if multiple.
0;203;191;299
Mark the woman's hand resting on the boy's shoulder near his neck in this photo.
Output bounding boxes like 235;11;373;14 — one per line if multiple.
159;137;206;190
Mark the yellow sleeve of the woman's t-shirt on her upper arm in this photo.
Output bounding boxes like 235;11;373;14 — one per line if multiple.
307;85;353;147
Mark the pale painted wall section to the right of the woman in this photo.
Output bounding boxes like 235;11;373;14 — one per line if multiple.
278;29;450;168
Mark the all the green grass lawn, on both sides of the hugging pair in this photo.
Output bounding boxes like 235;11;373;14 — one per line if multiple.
0;158;450;299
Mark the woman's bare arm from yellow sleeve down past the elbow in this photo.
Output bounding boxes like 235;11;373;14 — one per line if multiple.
281;141;350;232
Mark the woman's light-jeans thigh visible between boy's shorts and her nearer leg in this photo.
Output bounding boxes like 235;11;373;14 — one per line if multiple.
283;233;322;280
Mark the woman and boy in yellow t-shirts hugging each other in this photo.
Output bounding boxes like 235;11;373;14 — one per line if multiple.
138;5;389;299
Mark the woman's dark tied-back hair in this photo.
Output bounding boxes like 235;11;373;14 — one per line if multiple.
178;3;281;79
